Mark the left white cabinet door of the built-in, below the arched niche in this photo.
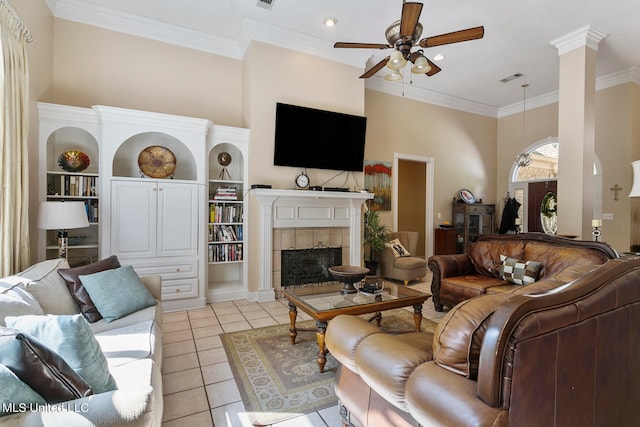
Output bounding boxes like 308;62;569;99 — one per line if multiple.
111;180;157;257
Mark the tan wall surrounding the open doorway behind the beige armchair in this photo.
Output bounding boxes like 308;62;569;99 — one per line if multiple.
365;90;497;231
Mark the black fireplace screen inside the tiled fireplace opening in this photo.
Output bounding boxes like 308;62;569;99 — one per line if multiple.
281;248;342;286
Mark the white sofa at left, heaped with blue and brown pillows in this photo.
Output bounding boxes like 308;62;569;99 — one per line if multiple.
0;259;163;427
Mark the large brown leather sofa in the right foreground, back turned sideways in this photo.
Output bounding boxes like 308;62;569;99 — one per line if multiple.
326;257;640;427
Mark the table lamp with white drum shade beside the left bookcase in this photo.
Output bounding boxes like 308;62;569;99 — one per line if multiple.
38;202;89;258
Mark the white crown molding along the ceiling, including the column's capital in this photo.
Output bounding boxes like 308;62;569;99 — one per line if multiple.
51;0;640;118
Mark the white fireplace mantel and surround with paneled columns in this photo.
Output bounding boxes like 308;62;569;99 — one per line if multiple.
251;189;373;302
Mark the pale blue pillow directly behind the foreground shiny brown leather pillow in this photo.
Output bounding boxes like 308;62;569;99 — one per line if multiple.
7;314;117;393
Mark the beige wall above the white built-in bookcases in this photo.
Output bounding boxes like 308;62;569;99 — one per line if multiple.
52;19;242;126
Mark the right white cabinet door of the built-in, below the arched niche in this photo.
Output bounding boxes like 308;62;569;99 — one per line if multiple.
157;182;200;256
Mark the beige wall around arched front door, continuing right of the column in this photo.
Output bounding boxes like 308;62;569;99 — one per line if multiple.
497;83;640;251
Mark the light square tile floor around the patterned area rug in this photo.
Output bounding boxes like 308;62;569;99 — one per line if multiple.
162;277;444;427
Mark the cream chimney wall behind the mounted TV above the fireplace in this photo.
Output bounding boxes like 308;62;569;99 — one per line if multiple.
243;42;364;291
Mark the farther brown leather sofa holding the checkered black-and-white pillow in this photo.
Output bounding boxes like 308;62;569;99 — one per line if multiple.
428;233;618;311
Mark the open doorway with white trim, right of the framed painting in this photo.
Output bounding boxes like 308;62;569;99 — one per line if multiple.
392;153;434;258
